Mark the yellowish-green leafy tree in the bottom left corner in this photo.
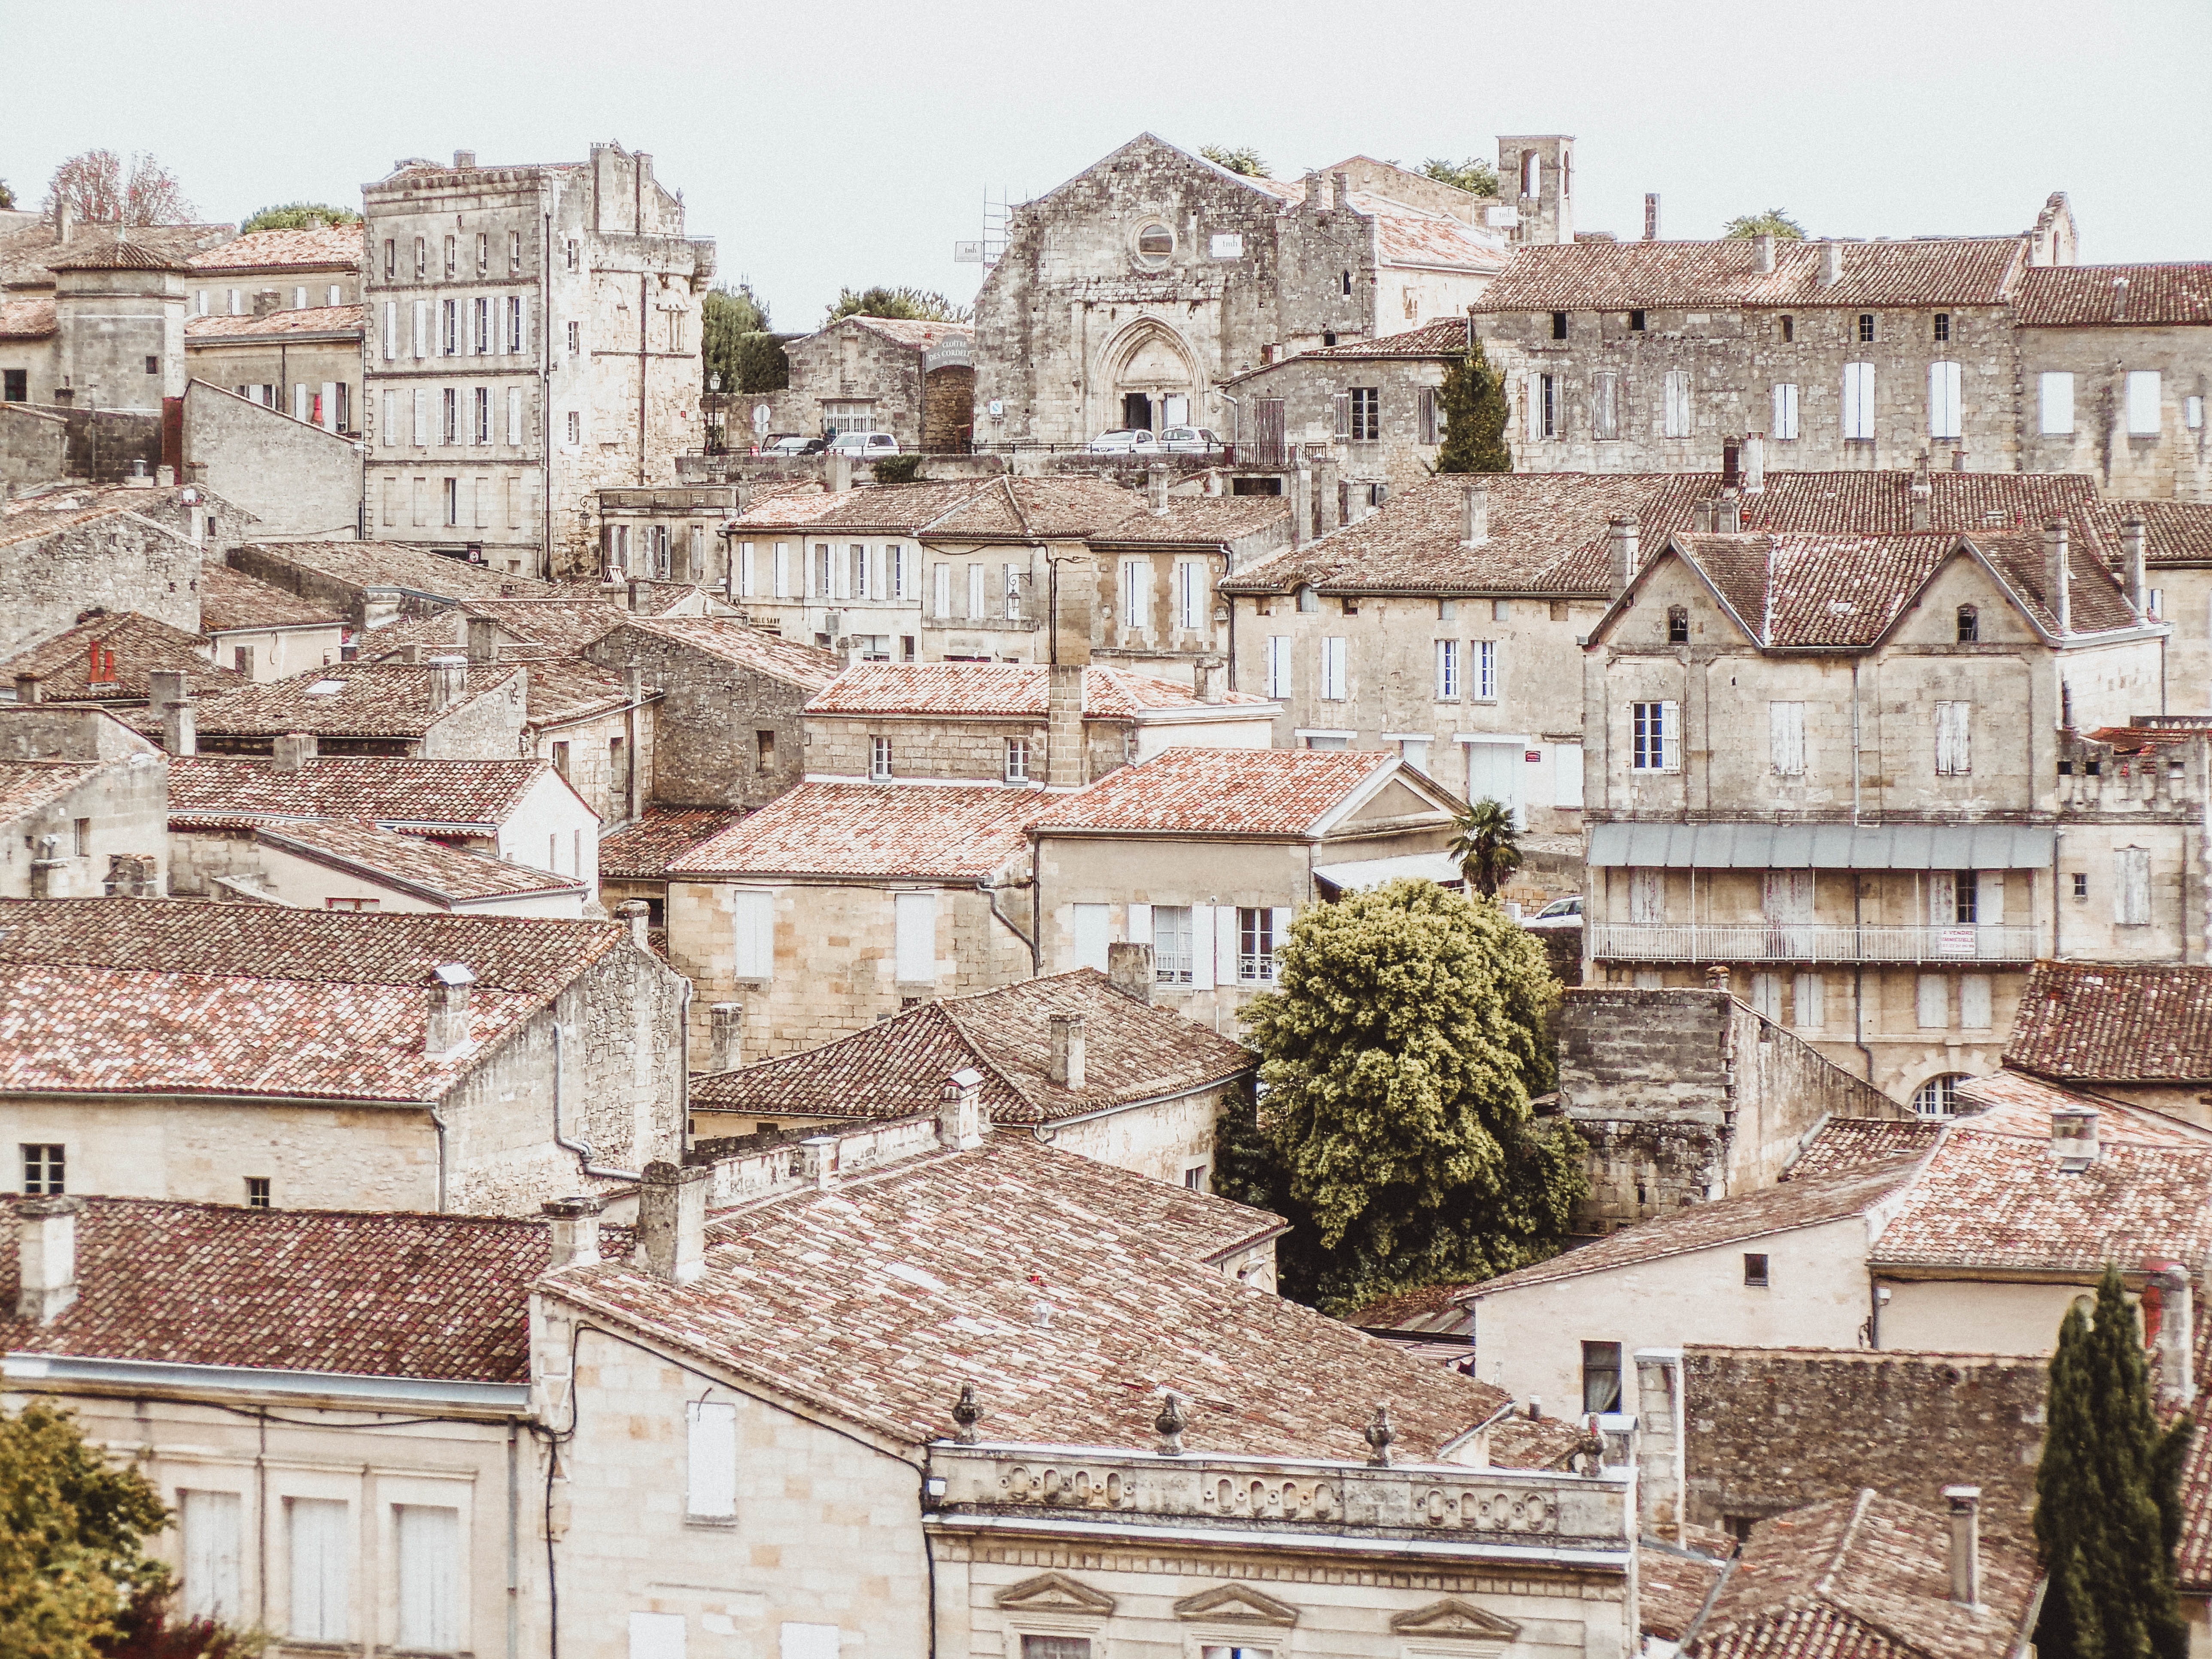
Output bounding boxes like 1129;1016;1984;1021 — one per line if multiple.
0;1400;168;1659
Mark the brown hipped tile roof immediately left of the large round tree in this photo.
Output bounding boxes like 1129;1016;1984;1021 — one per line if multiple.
693;969;1256;1124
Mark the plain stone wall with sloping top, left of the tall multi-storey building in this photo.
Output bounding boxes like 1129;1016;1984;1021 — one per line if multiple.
184;380;363;542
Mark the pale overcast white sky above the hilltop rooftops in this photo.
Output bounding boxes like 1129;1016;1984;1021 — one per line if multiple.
0;0;2212;330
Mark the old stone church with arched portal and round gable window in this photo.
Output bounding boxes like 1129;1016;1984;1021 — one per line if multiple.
975;133;1522;449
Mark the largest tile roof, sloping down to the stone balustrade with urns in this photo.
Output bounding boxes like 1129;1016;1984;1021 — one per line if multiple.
544;1135;1539;1460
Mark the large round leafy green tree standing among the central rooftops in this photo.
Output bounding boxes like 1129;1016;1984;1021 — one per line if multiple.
1217;880;1586;1312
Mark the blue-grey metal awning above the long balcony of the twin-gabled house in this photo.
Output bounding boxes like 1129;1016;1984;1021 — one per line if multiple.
1588;823;2057;869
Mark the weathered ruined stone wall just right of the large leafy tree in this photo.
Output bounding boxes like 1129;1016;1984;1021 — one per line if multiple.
1559;987;1909;1232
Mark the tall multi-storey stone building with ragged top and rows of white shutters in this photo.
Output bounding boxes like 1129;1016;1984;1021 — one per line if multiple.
361;144;714;575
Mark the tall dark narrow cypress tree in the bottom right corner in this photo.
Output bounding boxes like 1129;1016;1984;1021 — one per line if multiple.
2035;1267;2190;1659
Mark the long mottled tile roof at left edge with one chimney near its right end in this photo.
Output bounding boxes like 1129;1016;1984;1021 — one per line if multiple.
0;898;628;1102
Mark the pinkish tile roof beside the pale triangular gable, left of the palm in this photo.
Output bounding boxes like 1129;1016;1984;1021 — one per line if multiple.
1033;750;1396;836
